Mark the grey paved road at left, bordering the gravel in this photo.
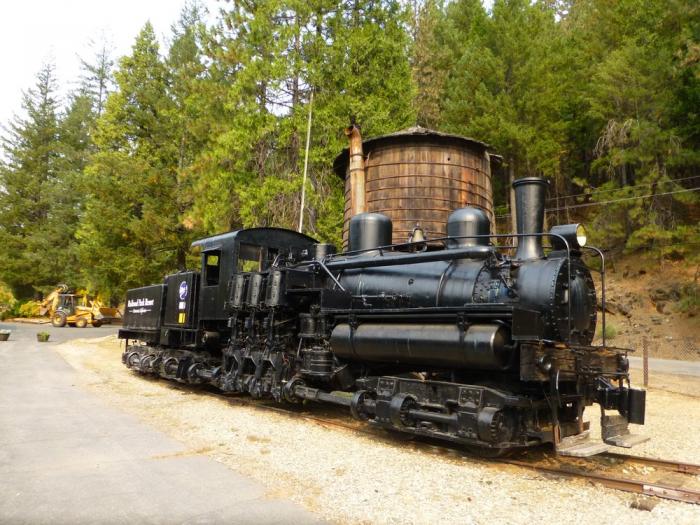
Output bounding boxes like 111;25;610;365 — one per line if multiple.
0;324;321;524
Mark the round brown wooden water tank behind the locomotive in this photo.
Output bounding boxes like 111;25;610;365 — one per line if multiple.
333;127;494;248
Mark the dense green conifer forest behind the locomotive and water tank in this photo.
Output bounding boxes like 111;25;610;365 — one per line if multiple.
0;0;700;300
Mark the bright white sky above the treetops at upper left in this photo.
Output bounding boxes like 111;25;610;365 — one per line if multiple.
0;0;221;129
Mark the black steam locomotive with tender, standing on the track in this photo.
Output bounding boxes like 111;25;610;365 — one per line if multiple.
119;178;645;455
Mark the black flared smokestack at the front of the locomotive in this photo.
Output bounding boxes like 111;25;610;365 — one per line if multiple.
513;177;549;261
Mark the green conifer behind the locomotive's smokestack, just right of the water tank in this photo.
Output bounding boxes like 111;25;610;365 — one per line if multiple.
443;0;565;229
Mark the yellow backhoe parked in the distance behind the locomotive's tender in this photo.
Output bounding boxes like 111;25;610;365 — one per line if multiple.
39;284;121;328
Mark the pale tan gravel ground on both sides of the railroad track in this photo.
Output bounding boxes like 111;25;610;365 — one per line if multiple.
52;337;700;525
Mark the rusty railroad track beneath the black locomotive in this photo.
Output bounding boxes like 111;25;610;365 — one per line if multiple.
163;384;700;505
